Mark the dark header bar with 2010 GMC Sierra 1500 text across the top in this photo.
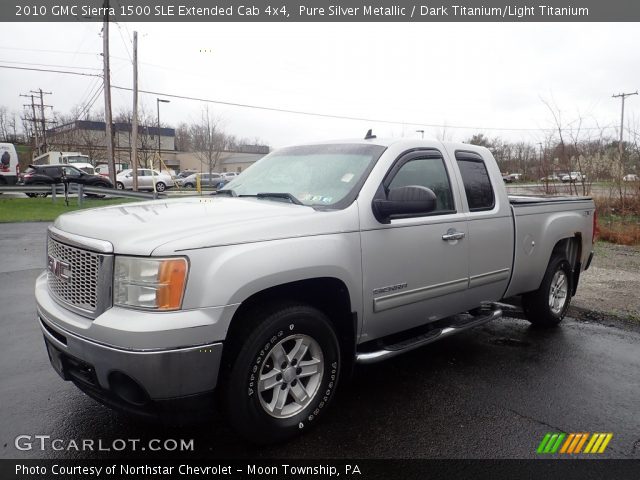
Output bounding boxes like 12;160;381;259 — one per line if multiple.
5;0;640;22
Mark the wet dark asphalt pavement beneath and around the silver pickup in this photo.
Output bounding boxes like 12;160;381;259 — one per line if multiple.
0;223;640;459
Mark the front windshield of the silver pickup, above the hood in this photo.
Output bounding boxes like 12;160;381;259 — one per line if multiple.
223;144;384;207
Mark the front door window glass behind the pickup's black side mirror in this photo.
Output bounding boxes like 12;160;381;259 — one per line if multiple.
389;158;455;214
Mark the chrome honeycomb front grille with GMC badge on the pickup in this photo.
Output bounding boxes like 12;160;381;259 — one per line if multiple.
47;238;103;313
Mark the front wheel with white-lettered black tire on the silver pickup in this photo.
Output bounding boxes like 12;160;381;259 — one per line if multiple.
221;304;341;444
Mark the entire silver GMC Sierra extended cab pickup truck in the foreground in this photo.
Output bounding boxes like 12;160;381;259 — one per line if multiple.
35;136;595;442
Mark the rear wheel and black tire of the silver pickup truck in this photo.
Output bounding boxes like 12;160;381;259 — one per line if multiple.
522;255;573;327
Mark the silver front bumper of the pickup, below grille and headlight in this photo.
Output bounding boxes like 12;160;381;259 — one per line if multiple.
36;272;222;409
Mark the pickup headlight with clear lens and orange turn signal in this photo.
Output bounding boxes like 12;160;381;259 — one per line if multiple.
113;256;189;310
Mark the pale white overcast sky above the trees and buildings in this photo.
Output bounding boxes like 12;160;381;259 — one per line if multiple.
0;23;640;147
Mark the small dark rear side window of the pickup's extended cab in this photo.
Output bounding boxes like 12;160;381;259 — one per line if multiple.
456;152;496;212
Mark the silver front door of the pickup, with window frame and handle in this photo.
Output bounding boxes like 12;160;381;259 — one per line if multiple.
361;150;469;339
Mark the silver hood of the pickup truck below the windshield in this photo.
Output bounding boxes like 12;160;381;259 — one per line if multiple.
54;197;358;255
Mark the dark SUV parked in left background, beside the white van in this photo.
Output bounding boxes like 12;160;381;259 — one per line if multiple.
17;164;113;197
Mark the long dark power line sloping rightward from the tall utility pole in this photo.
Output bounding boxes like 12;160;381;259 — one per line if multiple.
111;85;611;132
